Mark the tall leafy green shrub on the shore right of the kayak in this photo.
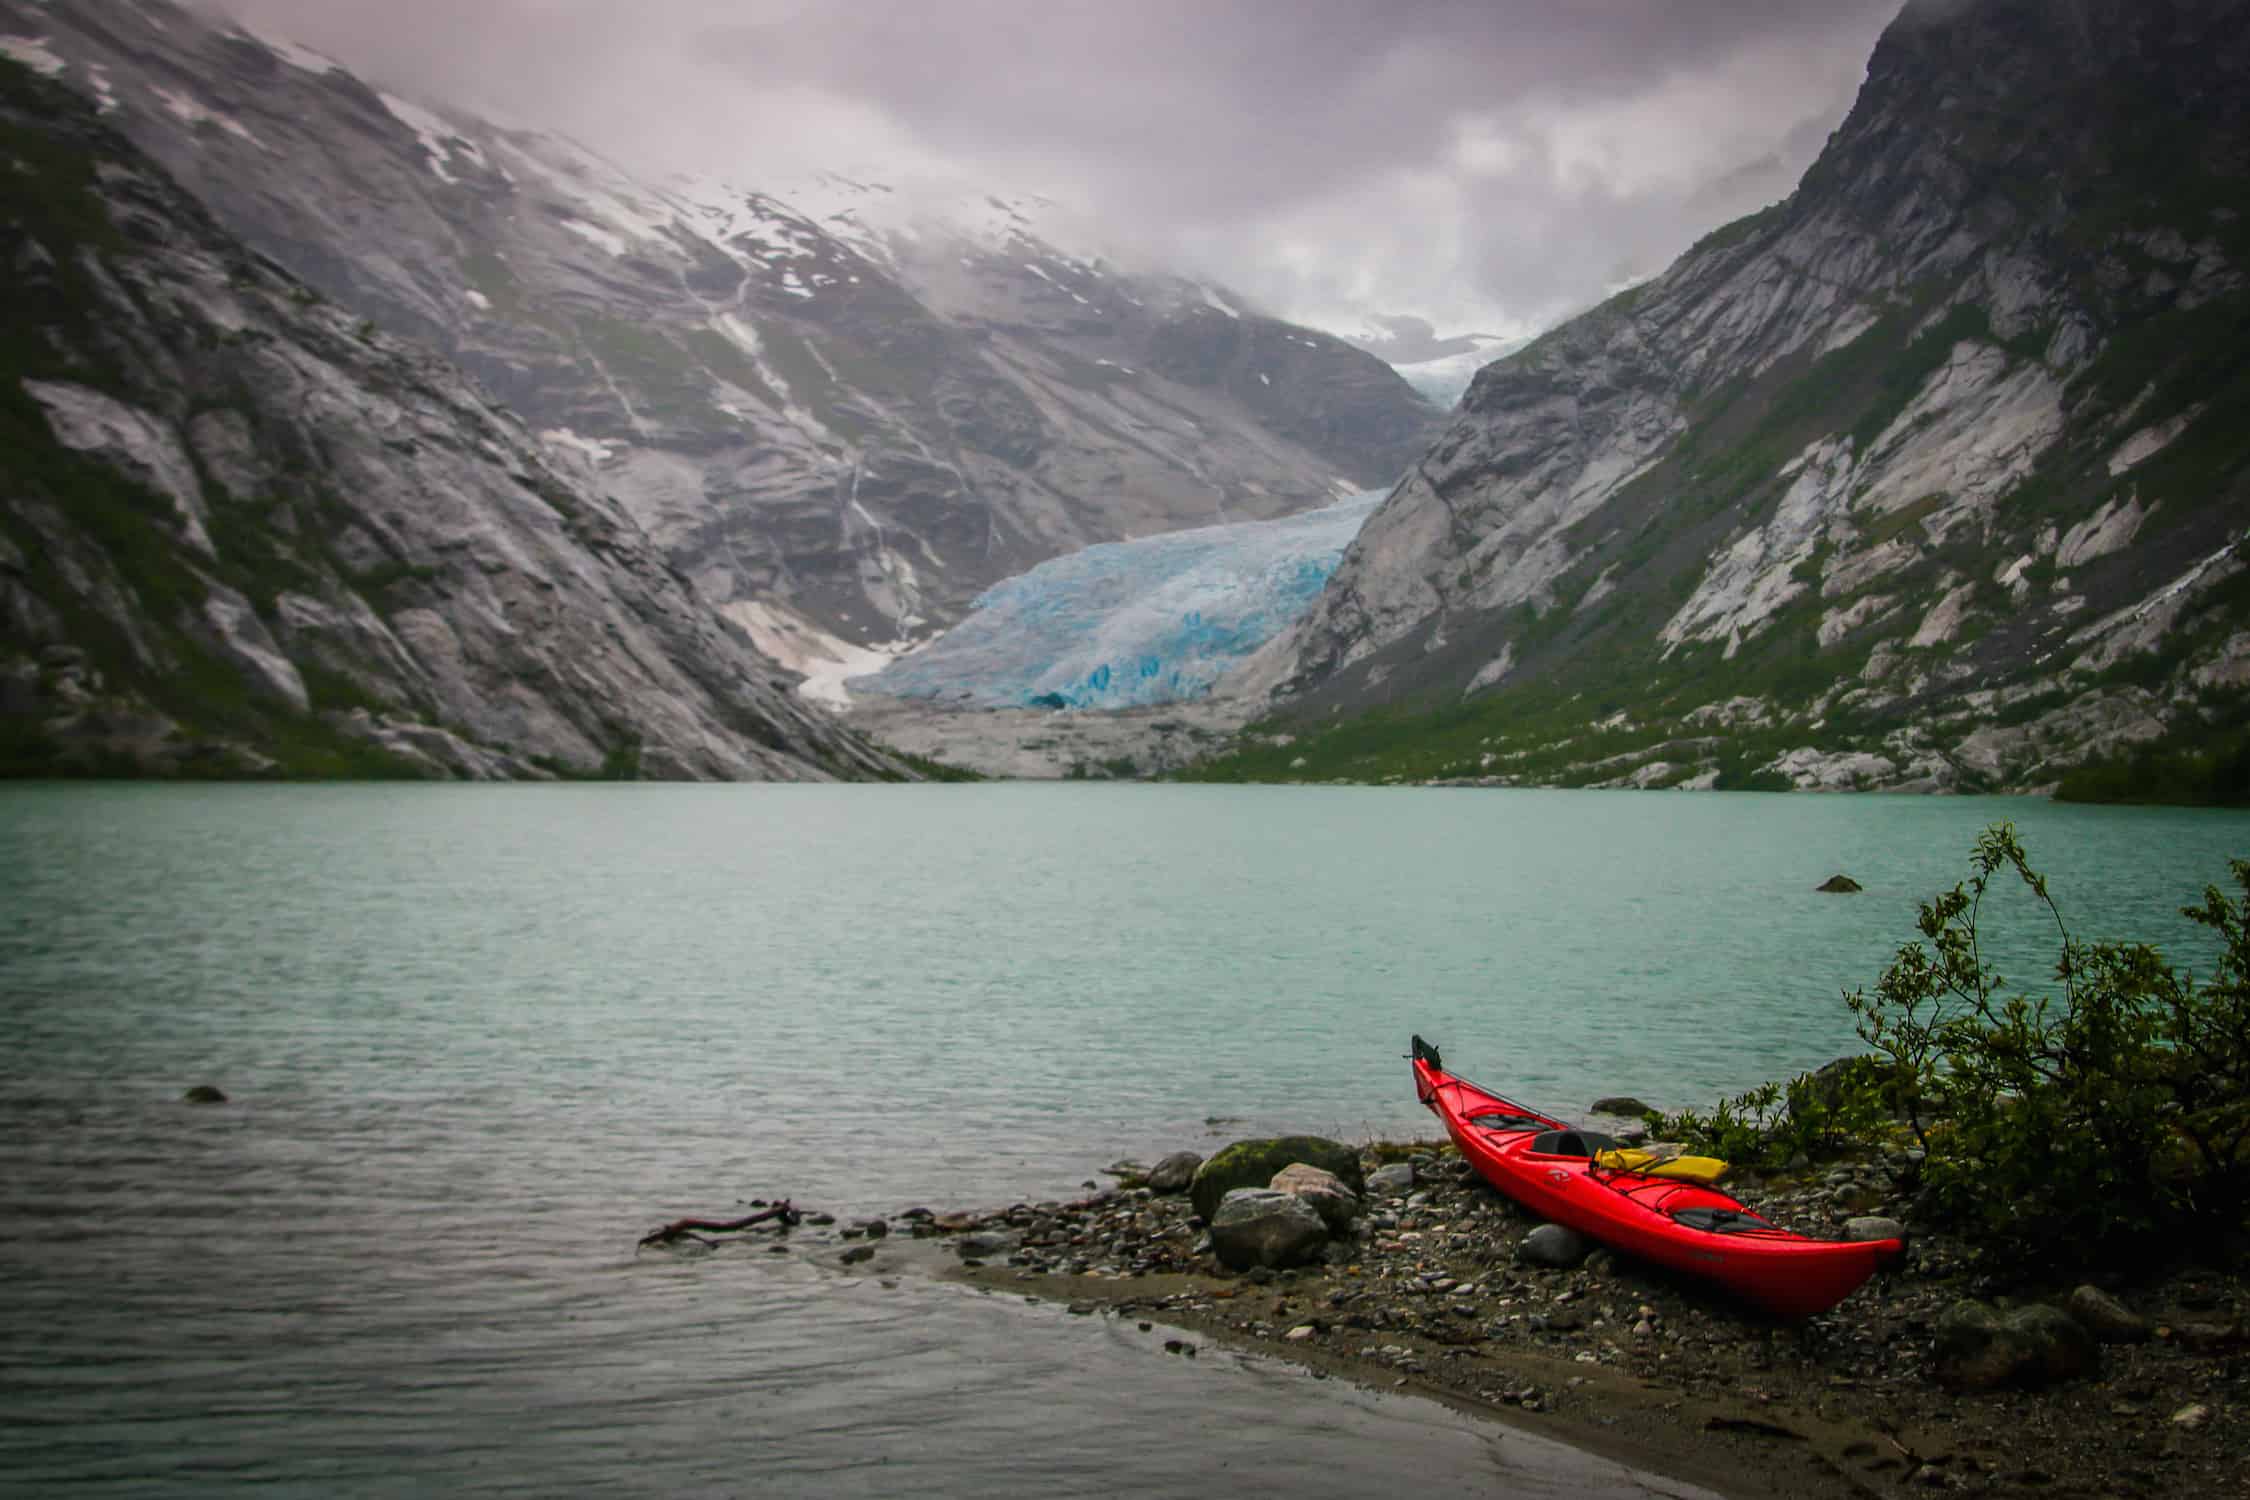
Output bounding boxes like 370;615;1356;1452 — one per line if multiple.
1845;823;2250;1259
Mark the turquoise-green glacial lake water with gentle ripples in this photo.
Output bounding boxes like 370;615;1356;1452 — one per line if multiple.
0;785;2250;1498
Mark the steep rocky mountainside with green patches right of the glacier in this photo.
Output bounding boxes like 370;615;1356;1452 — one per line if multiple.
1226;0;2250;787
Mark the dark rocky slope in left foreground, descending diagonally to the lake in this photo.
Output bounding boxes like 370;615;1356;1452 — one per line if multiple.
0;55;905;780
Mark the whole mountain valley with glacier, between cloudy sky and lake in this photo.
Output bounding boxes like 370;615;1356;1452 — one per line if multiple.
0;0;2250;798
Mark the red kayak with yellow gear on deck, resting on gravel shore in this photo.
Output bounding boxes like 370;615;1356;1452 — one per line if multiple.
1413;1037;1906;1318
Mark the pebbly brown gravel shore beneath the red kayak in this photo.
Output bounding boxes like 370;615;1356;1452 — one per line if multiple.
817;1145;2250;1498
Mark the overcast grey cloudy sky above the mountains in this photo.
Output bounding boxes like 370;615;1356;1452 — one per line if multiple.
207;0;1899;353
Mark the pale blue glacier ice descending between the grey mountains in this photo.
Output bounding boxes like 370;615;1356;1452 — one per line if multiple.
851;490;1388;708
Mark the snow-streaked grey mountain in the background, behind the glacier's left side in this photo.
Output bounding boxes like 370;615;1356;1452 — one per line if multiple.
0;0;1438;688
